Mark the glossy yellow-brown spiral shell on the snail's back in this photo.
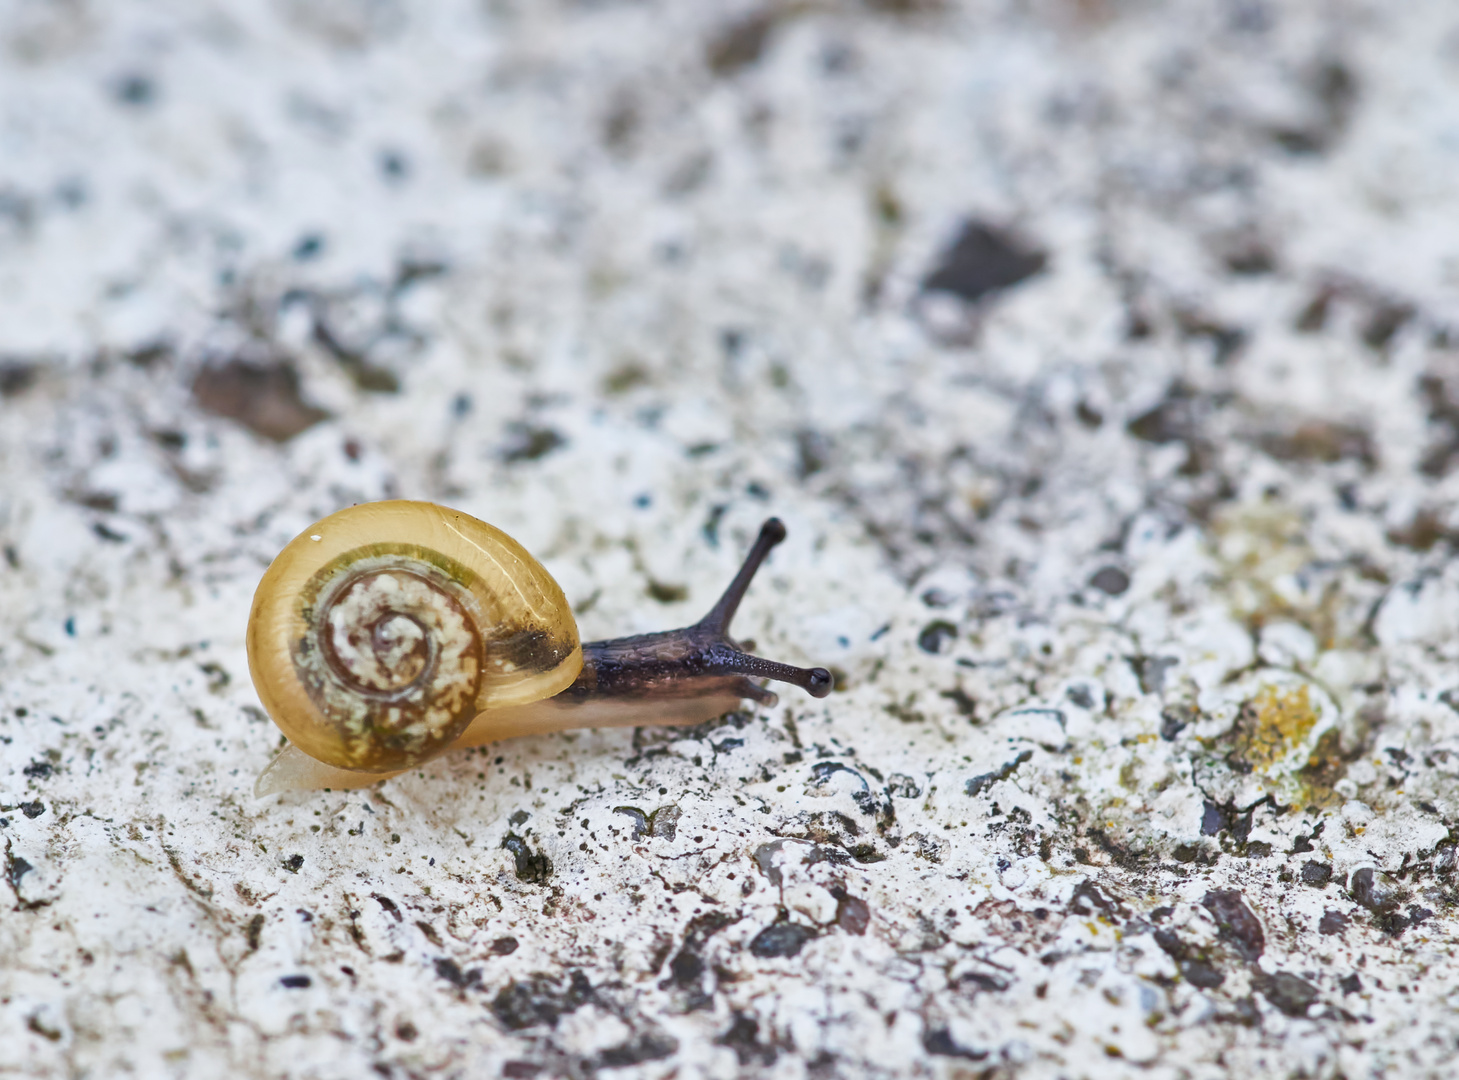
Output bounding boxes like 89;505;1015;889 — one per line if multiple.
248;499;582;774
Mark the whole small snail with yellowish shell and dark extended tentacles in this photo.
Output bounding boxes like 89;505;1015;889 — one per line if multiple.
248;499;832;795
